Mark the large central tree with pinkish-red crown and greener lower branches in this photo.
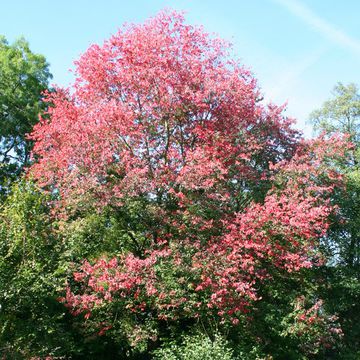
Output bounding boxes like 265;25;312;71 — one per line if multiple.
31;12;347;358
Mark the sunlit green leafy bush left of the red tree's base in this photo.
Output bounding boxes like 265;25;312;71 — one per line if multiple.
0;180;119;359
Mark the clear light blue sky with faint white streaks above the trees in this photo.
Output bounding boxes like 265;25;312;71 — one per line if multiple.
0;0;360;135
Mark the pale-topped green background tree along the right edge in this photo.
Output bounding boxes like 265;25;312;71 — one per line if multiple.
310;83;360;358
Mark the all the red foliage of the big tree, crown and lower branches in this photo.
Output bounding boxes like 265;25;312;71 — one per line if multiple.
31;12;344;332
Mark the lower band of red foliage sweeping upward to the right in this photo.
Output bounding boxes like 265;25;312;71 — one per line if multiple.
60;134;345;323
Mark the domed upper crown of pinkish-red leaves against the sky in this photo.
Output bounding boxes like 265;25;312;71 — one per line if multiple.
31;9;296;210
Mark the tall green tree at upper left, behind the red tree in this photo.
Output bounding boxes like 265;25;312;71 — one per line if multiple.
0;37;51;192
